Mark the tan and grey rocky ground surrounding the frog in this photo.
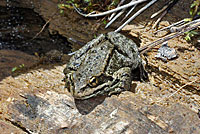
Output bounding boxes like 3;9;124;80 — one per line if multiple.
0;0;200;134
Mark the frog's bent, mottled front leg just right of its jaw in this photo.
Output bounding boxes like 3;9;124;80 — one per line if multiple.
107;67;132;96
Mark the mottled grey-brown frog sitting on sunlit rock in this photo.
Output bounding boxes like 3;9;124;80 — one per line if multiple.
63;32;146;100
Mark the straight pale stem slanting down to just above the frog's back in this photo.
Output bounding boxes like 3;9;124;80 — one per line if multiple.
115;0;157;32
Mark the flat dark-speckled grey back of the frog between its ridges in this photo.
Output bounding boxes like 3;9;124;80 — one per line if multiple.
73;40;114;90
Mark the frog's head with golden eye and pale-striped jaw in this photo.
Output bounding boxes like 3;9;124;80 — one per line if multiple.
65;68;118;99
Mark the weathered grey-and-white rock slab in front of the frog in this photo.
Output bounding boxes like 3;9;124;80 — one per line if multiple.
5;91;200;134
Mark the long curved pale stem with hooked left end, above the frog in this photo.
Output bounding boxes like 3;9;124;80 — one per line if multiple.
72;0;147;17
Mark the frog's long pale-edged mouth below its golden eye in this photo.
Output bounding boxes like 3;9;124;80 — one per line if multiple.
73;79;120;100
